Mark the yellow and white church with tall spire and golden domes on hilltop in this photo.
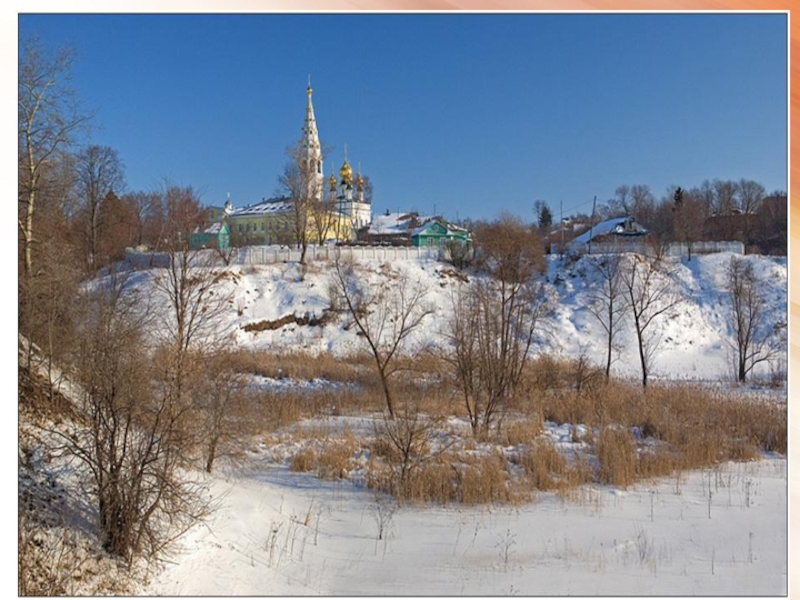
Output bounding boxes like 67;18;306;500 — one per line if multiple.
224;79;372;245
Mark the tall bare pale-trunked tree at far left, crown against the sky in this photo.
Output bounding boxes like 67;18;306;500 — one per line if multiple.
17;38;91;277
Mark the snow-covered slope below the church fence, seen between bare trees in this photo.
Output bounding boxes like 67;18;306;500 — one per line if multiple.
126;253;787;381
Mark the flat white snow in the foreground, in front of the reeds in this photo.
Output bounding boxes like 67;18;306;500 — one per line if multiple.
147;457;788;596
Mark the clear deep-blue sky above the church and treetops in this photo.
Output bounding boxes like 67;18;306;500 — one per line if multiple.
19;14;788;220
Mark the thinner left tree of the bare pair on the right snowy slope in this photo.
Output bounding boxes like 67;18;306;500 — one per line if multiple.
586;254;628;379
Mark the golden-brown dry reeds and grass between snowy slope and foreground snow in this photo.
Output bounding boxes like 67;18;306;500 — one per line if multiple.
241;346;787;505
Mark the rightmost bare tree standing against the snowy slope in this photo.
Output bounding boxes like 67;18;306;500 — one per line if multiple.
726;256;786;383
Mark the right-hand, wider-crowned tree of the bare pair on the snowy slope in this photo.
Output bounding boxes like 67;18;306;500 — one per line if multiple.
621;254;682;387
